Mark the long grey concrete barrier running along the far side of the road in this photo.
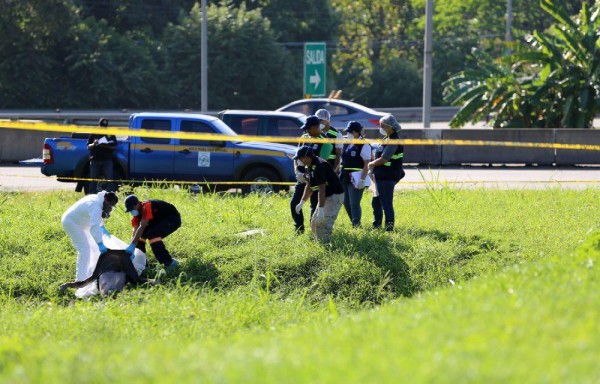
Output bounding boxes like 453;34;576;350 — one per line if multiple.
0;128;600;166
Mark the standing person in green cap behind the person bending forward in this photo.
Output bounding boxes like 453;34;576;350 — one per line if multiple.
290;116;333;234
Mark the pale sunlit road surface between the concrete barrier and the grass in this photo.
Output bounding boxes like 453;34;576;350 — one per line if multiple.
0;165;600;192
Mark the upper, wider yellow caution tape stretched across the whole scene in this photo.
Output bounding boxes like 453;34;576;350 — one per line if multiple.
0;121;600;151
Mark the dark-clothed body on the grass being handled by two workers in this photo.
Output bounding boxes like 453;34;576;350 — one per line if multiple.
59;249;156;296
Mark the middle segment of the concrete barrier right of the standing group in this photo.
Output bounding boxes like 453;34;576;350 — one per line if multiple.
442;129;555;165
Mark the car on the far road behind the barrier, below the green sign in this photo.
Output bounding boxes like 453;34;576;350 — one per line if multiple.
277;98;387;130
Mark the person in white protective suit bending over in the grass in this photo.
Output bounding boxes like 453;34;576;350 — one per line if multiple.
62;191;119;281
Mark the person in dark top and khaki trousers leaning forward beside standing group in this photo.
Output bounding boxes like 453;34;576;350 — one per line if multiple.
294;146;344;244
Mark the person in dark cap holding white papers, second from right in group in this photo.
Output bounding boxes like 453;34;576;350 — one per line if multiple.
340;121;371;227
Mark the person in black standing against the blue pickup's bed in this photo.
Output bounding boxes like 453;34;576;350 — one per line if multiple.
87;119;117;194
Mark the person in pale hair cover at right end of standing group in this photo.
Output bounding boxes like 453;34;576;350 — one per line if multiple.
369;115;404;231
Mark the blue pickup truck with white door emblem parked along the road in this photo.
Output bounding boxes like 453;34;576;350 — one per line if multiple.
41;112;296;192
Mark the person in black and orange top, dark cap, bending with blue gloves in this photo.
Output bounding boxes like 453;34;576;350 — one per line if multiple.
120;195;181;269
